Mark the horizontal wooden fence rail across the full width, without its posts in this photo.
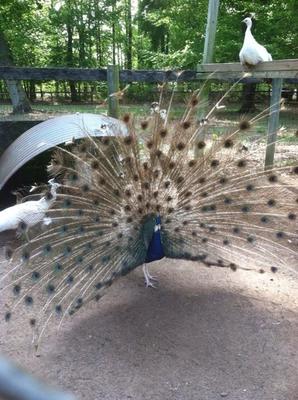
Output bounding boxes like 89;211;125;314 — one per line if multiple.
0;59;298;83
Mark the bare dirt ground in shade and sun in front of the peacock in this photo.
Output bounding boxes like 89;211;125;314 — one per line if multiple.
0;244;298;400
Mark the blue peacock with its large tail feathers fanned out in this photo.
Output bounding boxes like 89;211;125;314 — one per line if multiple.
2;79;298;345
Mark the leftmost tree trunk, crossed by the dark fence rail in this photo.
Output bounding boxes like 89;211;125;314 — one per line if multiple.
0;31;32;114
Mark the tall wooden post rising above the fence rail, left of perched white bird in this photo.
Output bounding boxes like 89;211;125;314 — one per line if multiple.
194;0;219;158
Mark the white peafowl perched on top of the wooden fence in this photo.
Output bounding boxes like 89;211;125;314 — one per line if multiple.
239;17;272;67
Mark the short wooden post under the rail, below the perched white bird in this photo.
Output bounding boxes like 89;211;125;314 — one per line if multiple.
265;78;283;169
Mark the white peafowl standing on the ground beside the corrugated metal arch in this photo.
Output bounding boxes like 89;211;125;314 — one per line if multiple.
0;179;60;238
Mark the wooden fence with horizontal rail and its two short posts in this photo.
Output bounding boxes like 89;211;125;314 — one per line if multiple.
0;59;298;168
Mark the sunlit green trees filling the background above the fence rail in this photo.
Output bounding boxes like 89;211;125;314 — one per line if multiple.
0;0;298;69
